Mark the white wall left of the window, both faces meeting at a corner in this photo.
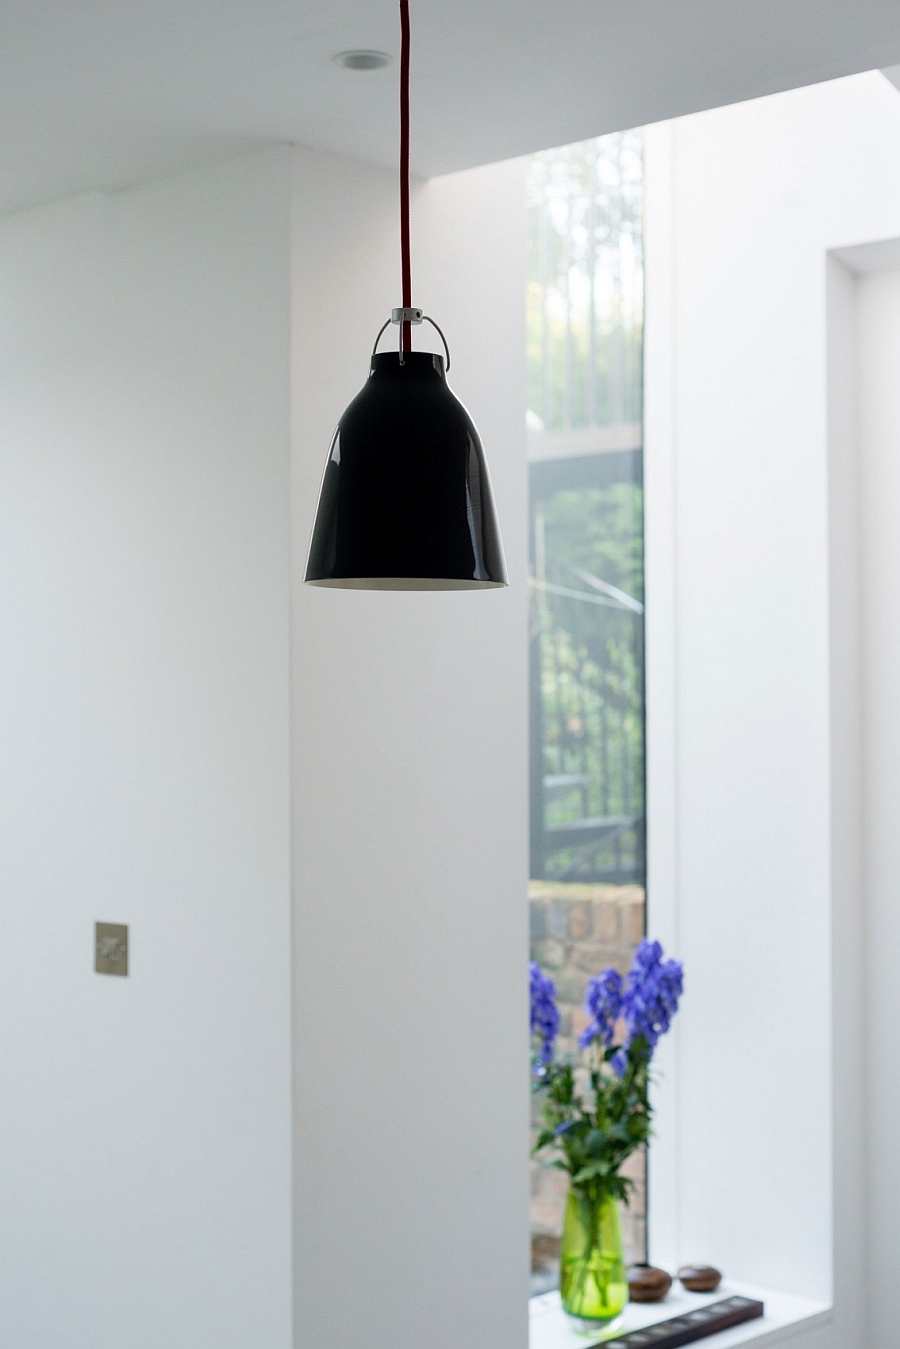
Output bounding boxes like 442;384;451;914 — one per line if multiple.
0;131;528;1349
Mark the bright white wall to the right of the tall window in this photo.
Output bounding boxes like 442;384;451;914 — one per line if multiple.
646;74;900;1349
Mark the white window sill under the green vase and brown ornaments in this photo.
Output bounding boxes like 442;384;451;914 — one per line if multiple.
529;1282;831;1349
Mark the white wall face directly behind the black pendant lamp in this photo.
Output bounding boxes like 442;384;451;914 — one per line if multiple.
293;150;528;1349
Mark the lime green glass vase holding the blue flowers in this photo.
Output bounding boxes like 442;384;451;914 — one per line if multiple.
560;1190;629;1325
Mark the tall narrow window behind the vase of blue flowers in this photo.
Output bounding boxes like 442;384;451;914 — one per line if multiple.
526;131;646;1292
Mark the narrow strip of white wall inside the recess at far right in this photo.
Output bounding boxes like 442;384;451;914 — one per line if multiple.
857;270;900;1349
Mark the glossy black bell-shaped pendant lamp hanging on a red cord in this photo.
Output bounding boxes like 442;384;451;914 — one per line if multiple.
306;0;507;590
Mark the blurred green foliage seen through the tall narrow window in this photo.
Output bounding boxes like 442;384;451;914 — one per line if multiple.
528;131;644;880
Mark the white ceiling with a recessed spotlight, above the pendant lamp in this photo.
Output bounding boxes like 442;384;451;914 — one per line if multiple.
0;0;900;210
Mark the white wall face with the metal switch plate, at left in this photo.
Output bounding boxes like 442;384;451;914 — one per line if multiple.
0;151;291;1349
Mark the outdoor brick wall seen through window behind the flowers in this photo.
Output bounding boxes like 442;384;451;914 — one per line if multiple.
529;881;646;1292
